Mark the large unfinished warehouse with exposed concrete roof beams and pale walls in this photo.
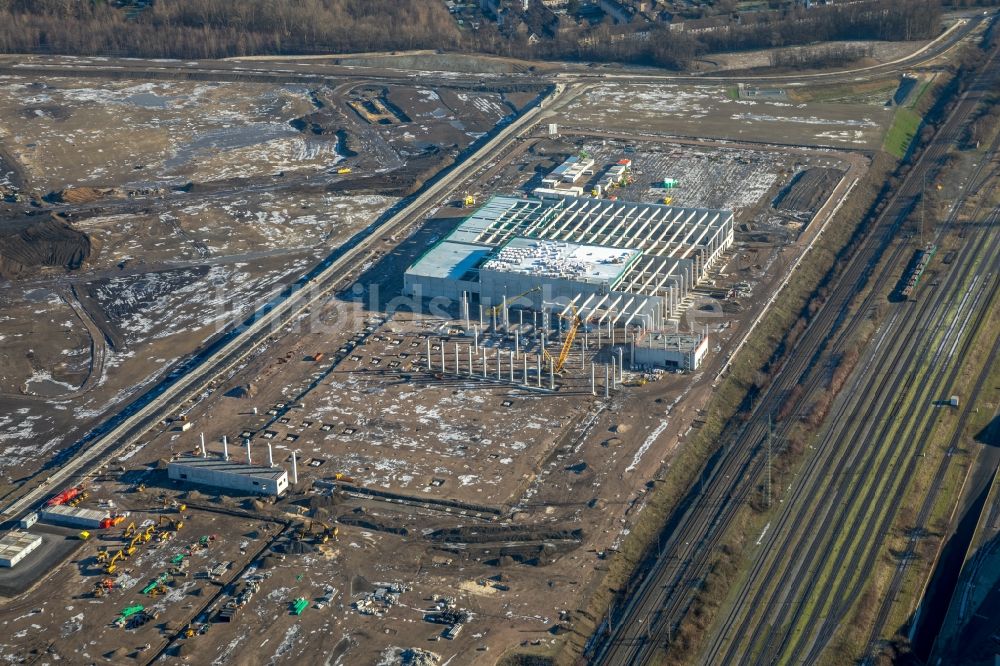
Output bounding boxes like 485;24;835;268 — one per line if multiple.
404;196;733;328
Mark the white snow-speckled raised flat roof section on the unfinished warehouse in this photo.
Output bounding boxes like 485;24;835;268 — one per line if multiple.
482;237;640;284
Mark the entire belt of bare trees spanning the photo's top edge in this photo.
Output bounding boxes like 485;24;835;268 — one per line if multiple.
0;0;948;68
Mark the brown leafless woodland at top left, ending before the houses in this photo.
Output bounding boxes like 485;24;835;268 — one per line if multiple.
0;0;461;58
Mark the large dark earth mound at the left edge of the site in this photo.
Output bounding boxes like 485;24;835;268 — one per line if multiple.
0;217;91;280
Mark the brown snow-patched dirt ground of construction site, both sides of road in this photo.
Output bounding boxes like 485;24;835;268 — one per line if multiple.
0;50;891;665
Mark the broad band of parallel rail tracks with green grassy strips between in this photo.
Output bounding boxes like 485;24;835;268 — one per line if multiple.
720;195;997;663
